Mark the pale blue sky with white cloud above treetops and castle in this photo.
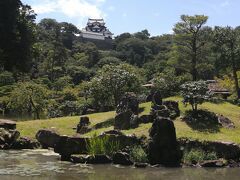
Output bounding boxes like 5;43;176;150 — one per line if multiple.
22;0;240;35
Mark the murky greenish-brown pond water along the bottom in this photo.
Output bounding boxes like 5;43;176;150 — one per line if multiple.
0;150;240;180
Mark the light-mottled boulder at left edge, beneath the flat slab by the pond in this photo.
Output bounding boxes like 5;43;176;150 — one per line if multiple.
0;128;20;149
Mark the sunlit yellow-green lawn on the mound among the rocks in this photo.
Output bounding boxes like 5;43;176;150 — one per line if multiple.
17;97;240;144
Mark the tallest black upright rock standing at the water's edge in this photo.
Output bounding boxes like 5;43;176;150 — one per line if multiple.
148;117;181;166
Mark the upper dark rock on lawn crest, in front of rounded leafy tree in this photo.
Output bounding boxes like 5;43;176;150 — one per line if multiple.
116;93;139;115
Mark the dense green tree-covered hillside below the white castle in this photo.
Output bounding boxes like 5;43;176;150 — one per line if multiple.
0;0;240;119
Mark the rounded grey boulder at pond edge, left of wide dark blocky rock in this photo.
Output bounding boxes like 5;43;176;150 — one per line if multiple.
36;129;60;148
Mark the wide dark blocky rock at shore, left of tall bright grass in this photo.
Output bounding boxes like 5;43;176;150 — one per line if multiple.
54;136;88;159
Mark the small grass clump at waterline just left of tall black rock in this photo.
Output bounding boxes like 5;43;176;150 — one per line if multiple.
130;146;148;163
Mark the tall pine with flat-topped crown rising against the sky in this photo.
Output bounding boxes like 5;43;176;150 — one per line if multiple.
173;15;208;81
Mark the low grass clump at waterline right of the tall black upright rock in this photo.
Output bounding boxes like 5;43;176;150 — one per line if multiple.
183;149;218;164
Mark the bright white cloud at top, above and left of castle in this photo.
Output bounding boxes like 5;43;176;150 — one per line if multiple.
32;0;105;19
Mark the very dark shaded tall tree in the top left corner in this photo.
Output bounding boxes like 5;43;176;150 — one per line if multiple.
0;0;36;72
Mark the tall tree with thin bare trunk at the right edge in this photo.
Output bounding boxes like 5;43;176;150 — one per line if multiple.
214;27;240;99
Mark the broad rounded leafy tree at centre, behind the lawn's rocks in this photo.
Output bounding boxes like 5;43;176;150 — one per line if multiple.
88;64;140;107
